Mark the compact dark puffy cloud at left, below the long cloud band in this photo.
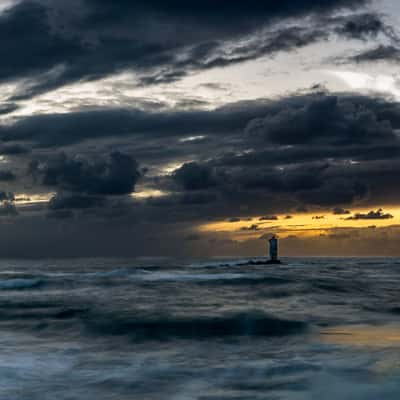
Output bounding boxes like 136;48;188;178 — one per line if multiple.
30;152;141;195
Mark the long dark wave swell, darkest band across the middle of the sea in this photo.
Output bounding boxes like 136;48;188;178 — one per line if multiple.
84;311;307;340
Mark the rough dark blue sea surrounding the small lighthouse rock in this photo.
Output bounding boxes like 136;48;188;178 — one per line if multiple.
0;258;400;400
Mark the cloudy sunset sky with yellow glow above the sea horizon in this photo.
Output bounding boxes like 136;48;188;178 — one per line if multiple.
0;0;400;258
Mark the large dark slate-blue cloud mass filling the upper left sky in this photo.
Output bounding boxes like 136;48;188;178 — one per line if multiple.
0;0;373;100
